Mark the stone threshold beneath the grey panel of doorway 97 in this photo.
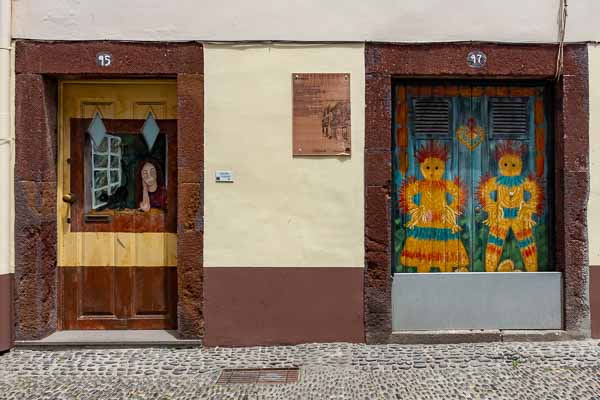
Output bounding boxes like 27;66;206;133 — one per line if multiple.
382;329;589;344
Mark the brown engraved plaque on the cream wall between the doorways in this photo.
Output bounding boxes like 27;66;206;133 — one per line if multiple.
292;74;351;156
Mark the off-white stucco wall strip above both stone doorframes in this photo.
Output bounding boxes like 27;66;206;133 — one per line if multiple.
13;0;600;42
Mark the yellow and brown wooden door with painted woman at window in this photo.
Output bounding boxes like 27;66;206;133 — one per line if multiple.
57;81;177;329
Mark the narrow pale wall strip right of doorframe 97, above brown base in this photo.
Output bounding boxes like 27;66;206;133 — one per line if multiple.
588;45;600;265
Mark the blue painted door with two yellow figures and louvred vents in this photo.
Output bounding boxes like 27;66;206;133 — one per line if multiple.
393;84;553;272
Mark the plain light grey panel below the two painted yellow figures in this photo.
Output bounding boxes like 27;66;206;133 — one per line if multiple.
392;272;562;331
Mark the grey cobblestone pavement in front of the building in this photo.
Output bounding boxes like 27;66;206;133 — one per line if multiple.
0;341;600;400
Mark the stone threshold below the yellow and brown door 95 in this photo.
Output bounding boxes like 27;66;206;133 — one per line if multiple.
15;330;202;347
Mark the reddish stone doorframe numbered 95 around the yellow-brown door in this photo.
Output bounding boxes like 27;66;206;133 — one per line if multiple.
15;40;204;340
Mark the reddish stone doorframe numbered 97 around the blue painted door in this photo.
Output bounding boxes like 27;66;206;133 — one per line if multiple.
365;43;590;343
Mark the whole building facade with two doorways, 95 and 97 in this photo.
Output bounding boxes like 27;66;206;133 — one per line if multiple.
0;0;600;349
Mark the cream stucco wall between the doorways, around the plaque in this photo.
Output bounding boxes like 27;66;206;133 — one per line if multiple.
204;44;365;267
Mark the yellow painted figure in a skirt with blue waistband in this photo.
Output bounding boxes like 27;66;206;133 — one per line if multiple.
400;141;469;272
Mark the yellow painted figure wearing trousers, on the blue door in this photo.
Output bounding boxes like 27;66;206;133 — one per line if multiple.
479;141;542;272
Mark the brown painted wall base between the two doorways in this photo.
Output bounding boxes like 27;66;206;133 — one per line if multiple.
204;267;364;346
